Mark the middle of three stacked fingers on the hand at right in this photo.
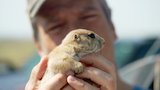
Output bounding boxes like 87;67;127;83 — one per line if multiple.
76;67;116;90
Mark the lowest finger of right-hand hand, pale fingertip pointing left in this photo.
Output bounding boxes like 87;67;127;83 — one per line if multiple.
67;75;99;90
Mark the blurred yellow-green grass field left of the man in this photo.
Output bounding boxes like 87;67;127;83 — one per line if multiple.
0;40;36;69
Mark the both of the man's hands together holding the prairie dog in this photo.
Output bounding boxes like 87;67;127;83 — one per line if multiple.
25;56;117;90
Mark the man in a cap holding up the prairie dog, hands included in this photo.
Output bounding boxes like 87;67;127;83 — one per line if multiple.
26;0;133;90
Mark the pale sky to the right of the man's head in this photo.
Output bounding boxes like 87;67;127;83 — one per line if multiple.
107;0;160;38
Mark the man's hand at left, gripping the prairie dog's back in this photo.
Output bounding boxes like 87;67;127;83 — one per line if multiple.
25;57;72;90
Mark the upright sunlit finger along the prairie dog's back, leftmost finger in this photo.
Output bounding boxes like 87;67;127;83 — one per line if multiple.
25;56;48;90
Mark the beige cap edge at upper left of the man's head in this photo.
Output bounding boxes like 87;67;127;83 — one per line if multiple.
27;0;46;18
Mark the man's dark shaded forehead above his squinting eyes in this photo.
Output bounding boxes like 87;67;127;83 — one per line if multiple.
38;0;97;16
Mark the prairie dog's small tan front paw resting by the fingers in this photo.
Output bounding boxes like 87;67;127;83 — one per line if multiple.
73;62;84;74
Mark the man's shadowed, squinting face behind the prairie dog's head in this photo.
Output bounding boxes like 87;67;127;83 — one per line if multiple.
37;0;116;61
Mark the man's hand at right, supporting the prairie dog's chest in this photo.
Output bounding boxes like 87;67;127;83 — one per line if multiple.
67;56;117;90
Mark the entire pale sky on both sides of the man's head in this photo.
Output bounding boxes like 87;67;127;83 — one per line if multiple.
0;0;160;39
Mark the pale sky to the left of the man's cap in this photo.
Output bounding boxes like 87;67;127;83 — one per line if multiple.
0;0;32;39
